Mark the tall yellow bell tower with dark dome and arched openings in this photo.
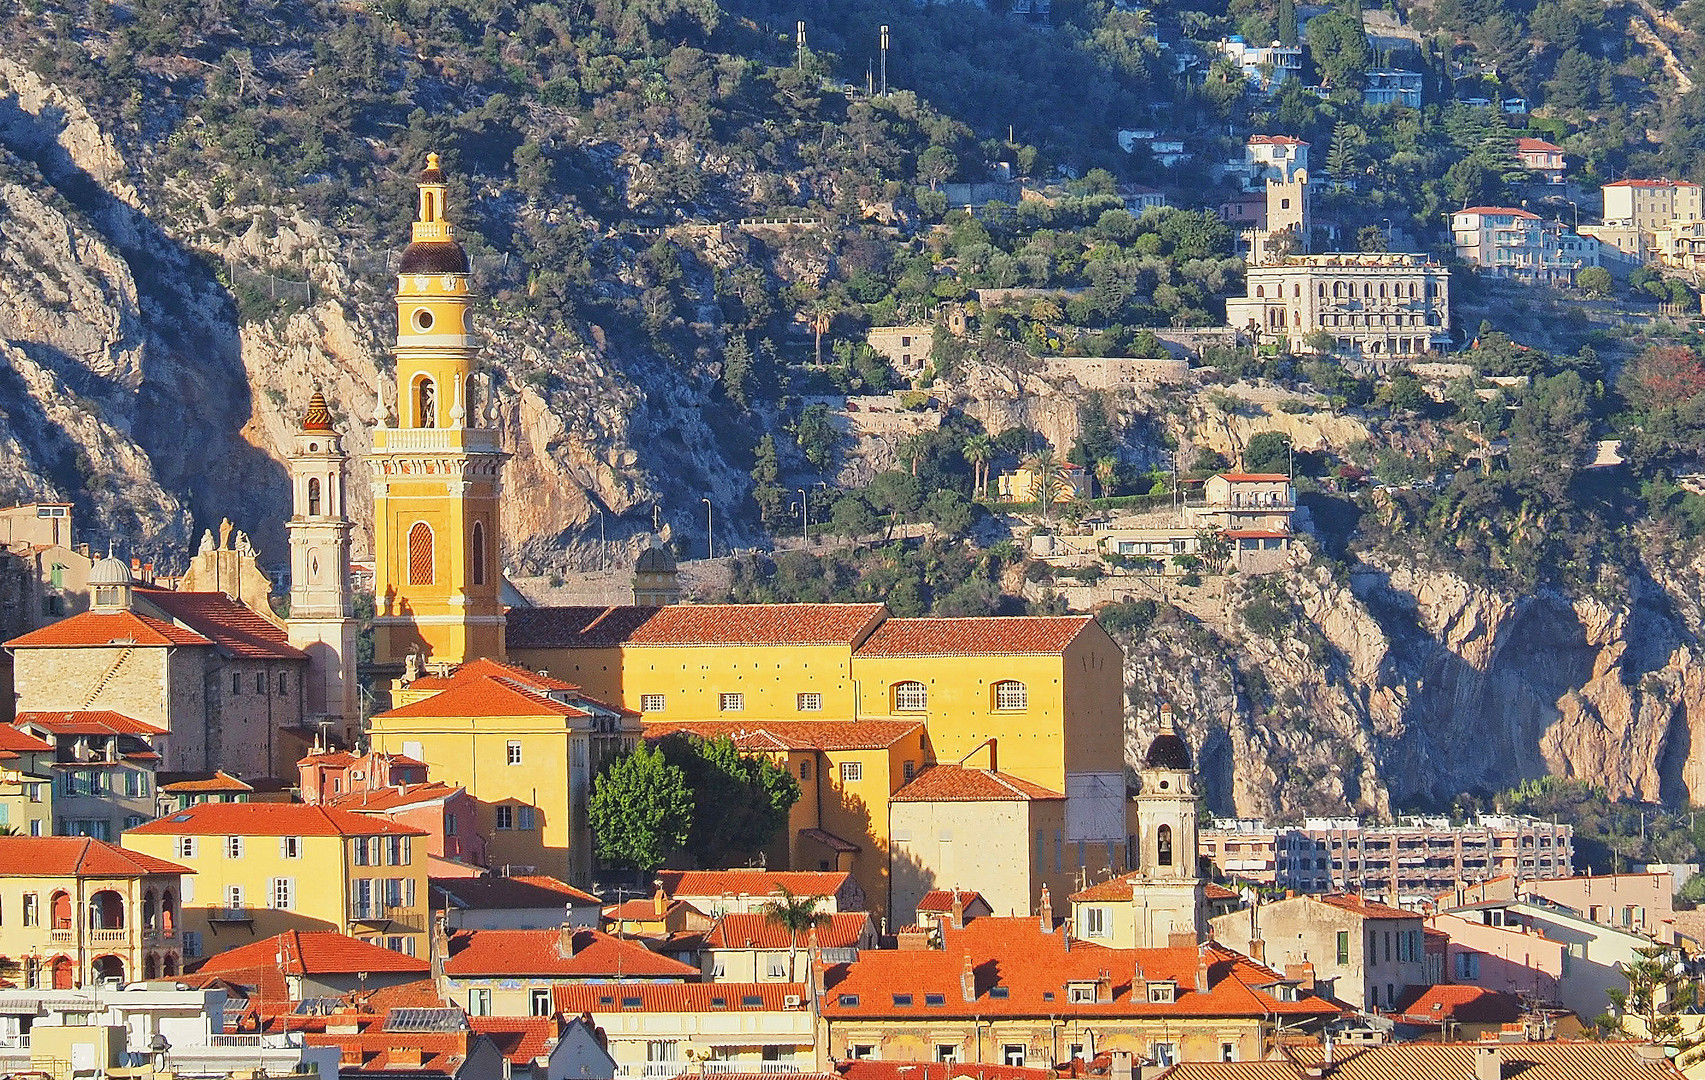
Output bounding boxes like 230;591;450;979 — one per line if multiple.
368;154;508;669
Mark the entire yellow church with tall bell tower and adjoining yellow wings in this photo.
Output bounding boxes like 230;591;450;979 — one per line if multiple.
359;160;1130;918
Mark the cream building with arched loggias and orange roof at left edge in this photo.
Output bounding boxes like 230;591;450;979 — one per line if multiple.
0;836;193;990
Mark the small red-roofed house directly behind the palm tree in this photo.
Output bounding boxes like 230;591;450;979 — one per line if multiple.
699;911;876;983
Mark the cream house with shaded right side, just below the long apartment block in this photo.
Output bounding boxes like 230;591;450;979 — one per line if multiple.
1209;894;1429;1012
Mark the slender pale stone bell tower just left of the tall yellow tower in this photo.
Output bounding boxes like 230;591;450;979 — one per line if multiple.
285;391;361;737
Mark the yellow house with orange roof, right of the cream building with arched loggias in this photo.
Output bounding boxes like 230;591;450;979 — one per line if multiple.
124;802;430;957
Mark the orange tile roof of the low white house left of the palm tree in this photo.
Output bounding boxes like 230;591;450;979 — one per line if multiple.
443;928;699;979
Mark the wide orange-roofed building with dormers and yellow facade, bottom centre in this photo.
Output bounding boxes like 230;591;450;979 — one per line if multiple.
822;916;1342;1066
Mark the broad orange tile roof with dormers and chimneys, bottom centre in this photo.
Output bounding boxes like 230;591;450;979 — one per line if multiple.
822;916;1340;1022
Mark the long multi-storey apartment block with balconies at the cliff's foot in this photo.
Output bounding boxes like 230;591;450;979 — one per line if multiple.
1200;816;1574;899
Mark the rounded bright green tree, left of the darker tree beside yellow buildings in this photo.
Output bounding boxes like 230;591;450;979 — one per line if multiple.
587;744;692;872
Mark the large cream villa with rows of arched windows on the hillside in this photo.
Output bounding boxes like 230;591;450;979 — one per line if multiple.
1226;253;1451;360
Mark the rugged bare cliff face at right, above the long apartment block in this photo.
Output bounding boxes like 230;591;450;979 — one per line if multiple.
1127;545;1705;816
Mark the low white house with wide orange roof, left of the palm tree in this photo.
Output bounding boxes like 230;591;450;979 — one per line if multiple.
442;926;699;1017
